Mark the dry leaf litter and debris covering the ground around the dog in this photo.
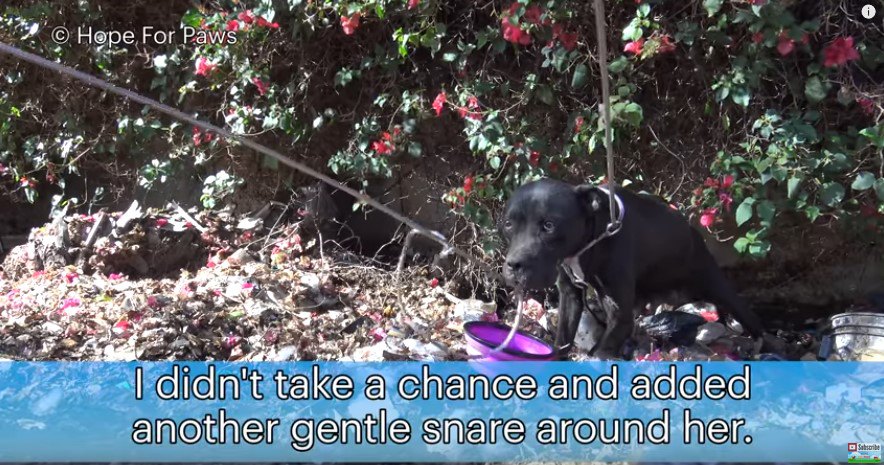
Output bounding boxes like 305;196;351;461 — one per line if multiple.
0;203;876;361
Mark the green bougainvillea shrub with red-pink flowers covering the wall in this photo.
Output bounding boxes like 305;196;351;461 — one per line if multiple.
0;0;884;256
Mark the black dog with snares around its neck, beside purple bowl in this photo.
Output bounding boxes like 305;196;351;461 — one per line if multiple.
501;179;763;359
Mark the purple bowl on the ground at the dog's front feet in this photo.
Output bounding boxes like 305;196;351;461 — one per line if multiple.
463;321;555;361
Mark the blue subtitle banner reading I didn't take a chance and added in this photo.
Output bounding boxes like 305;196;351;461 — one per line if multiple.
0;362;884;462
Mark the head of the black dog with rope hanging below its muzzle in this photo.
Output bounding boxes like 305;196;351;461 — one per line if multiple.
499;179;604;290
